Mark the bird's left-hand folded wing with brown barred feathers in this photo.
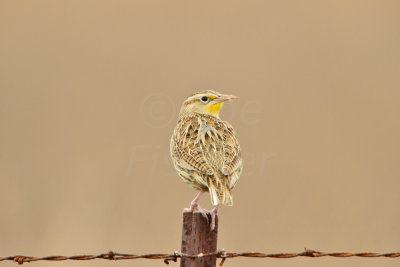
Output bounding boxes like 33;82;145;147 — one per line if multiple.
171;116;214;180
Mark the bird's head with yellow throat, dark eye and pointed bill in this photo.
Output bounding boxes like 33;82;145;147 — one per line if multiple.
179;90;239;117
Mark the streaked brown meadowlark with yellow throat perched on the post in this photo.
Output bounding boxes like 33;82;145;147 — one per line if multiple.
170;90;243;230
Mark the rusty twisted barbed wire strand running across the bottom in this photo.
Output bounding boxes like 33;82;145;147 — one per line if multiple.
0;249;400;266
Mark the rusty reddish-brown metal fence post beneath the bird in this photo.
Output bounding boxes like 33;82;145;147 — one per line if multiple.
181;212;218;267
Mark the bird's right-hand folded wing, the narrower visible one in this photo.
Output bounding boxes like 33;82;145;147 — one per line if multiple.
222;121;242;178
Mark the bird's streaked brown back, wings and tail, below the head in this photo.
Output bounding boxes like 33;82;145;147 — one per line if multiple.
171;113;243;205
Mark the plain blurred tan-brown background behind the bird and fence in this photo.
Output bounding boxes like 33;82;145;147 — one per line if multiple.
0;0;400;267
